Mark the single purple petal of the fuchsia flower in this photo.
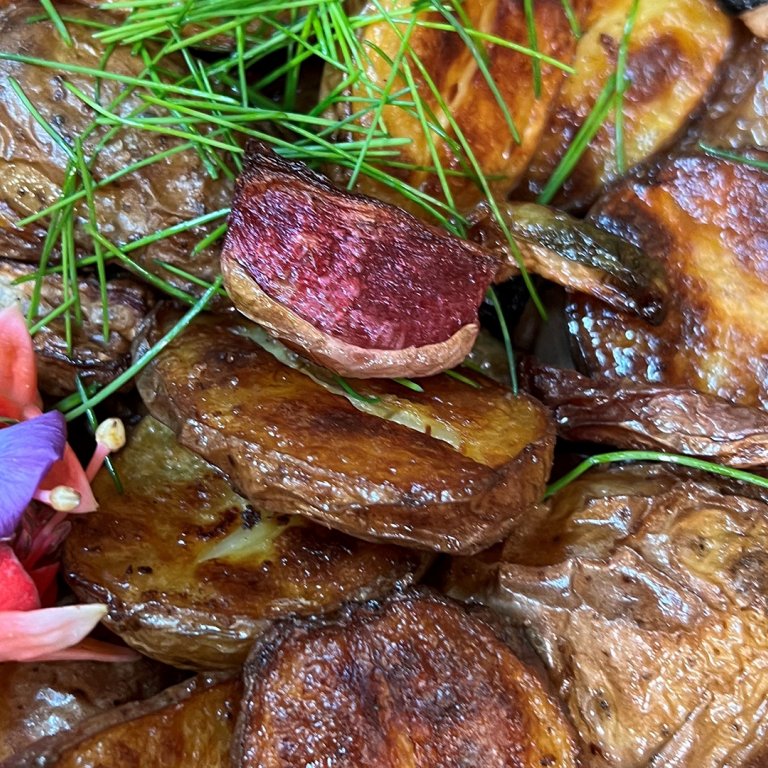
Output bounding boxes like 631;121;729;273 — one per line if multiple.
0;411;67;538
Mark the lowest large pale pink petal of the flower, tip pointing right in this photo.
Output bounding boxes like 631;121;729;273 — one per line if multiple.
0;603;107;661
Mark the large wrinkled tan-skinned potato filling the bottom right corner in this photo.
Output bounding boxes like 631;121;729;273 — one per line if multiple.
451;465;768;768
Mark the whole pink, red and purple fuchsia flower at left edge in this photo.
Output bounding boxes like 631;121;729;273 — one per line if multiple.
0;306;136;662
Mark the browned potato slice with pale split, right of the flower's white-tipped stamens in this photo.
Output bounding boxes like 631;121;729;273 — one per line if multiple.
64;417;429;669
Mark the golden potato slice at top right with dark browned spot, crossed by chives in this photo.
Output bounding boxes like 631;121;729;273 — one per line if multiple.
515;0;731;210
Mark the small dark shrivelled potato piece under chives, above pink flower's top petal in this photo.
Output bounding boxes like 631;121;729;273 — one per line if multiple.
0;259;154;396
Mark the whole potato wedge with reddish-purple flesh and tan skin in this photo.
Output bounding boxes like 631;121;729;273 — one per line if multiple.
221;144;496;377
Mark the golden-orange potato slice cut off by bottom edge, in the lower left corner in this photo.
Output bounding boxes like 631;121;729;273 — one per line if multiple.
2;675;237;768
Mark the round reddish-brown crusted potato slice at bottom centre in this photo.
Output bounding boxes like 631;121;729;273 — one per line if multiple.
233;593;576;768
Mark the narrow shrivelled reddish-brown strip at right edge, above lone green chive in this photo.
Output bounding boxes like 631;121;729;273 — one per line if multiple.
527;366;768;467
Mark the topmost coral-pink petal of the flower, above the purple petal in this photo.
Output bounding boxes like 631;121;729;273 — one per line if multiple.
0;304;41;418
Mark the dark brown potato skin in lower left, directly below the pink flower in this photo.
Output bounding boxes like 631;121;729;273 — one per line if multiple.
0;659;179;760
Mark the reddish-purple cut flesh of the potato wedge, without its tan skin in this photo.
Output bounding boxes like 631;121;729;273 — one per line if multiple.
222;150;495;349
